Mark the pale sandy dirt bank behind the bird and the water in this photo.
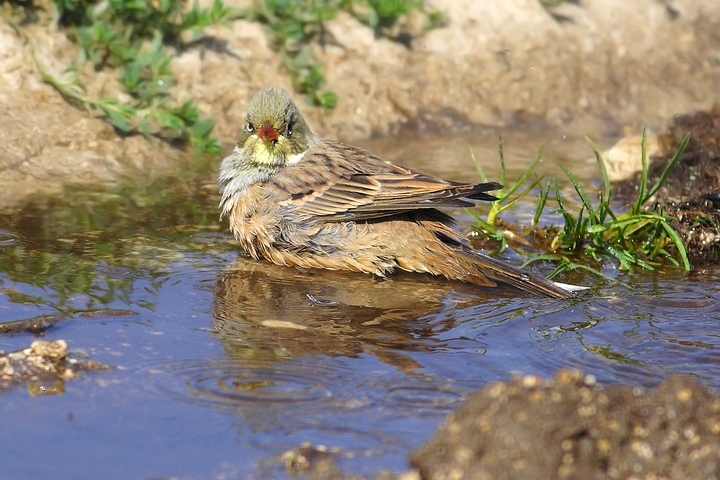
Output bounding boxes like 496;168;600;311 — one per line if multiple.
0;0;720;208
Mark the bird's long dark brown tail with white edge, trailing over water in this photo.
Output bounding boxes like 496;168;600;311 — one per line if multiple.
459;248;588;298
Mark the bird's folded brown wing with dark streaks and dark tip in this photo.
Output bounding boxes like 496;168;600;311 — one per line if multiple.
267;142;501;221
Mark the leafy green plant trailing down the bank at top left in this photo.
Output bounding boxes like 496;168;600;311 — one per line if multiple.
6;0;242;153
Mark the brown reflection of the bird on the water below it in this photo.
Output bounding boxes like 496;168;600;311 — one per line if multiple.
213;257;517;371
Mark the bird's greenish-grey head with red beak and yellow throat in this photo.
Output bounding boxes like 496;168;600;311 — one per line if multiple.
238;88;313;167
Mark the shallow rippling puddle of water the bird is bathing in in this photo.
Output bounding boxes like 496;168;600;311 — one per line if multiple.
0;133;720;479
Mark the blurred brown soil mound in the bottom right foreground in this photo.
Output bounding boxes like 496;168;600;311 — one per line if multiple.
412;371;720;480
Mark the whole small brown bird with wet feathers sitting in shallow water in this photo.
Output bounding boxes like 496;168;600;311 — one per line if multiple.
219;88;579;298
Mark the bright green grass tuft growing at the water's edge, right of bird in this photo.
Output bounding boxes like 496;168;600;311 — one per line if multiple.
476;134;690;277
